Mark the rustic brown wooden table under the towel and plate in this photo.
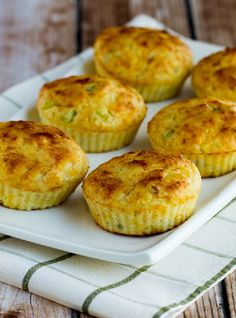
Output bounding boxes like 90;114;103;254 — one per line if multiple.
0;0;236;318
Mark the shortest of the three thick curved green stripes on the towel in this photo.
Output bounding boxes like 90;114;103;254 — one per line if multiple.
22;253;75;291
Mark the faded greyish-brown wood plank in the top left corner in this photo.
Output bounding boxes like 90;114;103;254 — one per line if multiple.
0;0;76;91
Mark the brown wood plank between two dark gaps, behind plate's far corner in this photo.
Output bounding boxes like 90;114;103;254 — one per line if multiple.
81;0;189;49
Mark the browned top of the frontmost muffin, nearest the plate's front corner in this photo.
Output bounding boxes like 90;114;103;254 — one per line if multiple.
83;150;201;207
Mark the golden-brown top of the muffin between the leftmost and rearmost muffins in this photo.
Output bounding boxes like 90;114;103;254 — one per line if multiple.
37;75;146;132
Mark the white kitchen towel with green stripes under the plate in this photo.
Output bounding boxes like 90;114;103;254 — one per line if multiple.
0;200;236;318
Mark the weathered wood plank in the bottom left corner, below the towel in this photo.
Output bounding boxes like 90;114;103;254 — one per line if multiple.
0;283;71;318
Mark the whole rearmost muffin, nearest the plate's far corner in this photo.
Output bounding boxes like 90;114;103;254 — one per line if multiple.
94;26;192;102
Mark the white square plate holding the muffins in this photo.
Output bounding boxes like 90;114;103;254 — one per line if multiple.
0;16;236;265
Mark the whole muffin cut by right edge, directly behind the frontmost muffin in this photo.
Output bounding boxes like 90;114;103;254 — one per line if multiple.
148;97;236;177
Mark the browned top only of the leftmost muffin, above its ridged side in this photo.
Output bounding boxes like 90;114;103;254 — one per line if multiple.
0;121;88;192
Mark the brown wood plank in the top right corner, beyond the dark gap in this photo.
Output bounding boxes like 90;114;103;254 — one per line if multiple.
189;0;236;46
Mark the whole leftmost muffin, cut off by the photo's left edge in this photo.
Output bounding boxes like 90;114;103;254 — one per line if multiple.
0;121;88;210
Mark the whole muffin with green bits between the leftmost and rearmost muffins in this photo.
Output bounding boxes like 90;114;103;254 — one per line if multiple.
37;75;146;152
